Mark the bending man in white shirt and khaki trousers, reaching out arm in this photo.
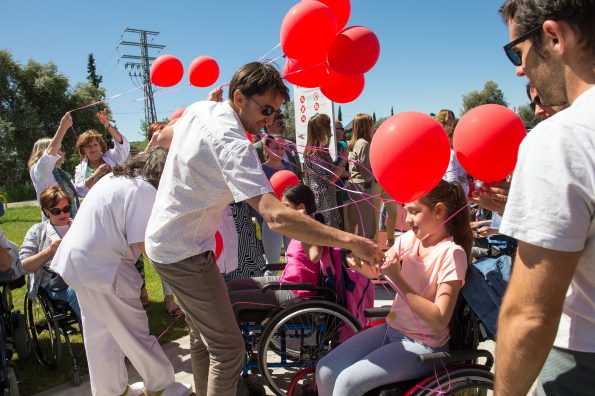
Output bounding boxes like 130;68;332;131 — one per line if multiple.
145;62;382;396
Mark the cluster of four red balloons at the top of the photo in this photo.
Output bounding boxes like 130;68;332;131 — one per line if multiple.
281;0;380;103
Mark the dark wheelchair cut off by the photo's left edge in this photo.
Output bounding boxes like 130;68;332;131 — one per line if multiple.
0;272;30;396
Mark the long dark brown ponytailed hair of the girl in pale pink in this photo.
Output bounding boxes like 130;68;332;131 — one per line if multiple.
419;180;473;261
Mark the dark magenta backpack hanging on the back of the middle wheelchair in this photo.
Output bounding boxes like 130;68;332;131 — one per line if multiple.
323;248;374;341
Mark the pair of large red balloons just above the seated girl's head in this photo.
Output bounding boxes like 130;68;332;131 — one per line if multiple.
370;104;527;203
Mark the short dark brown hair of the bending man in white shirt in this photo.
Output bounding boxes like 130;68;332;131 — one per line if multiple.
229;62;289;102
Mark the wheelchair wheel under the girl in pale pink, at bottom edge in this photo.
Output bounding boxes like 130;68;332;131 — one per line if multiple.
410;366;494;396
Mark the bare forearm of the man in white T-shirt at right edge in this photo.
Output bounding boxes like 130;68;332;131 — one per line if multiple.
495;242;581;395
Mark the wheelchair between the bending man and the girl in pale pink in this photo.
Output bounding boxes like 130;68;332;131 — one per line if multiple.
238;264;361;395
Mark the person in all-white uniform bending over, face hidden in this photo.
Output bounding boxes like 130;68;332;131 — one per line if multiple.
51;148;190;396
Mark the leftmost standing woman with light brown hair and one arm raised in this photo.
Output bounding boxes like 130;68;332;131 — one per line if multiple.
27;113;79;220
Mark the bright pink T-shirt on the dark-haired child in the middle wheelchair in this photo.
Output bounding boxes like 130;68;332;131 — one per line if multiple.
279;239;328;297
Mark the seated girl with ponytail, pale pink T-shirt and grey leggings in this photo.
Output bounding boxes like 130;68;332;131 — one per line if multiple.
316;180;473;396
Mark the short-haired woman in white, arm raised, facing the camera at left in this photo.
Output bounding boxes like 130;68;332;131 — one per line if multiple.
74;109;130;197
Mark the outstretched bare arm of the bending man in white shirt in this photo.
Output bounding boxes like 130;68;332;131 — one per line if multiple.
246;193;384;264
